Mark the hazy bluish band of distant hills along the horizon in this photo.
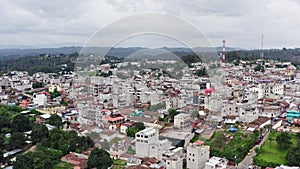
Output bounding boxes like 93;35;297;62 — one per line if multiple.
0;46;300;65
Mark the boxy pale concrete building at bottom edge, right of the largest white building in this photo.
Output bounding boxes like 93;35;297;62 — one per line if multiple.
186;143;210;169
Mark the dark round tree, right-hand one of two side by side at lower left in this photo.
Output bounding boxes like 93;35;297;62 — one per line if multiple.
31;124;49;144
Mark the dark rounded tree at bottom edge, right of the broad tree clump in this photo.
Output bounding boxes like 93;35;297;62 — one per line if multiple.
88;148;113;169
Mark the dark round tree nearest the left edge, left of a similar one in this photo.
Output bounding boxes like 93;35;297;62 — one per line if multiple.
11;114;31;132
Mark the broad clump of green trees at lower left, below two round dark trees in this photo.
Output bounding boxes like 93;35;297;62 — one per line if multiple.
13;129;93;169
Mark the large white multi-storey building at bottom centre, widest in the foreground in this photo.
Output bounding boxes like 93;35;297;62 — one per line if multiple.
135;127;171;159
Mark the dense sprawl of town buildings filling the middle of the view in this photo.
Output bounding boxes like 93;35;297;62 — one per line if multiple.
0;57;300;169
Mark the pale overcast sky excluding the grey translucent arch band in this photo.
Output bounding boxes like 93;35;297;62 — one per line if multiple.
0;0;300;49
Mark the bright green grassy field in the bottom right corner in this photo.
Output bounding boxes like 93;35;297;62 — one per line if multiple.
255;132;297;164
